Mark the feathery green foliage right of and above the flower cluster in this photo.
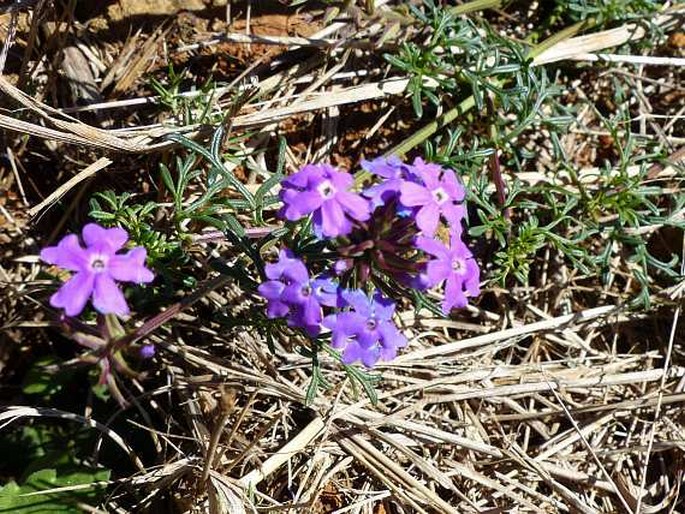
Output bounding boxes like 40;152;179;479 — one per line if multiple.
385;0;683;304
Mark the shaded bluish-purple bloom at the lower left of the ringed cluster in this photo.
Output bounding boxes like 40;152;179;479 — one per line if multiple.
257;249;340;336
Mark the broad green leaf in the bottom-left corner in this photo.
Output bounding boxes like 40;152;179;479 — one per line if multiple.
0;468;109;514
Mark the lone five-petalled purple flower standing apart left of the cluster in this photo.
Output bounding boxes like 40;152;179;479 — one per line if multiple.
40;223;154;316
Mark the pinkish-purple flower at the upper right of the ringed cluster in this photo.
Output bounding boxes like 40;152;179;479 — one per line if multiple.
400;157;465;237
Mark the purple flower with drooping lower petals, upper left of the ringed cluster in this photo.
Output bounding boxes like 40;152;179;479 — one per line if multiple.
280;164;370;238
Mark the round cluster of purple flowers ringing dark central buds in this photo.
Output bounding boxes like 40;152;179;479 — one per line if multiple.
259;156;480;366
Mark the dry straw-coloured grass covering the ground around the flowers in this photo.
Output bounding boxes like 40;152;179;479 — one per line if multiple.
0;1;685;514
